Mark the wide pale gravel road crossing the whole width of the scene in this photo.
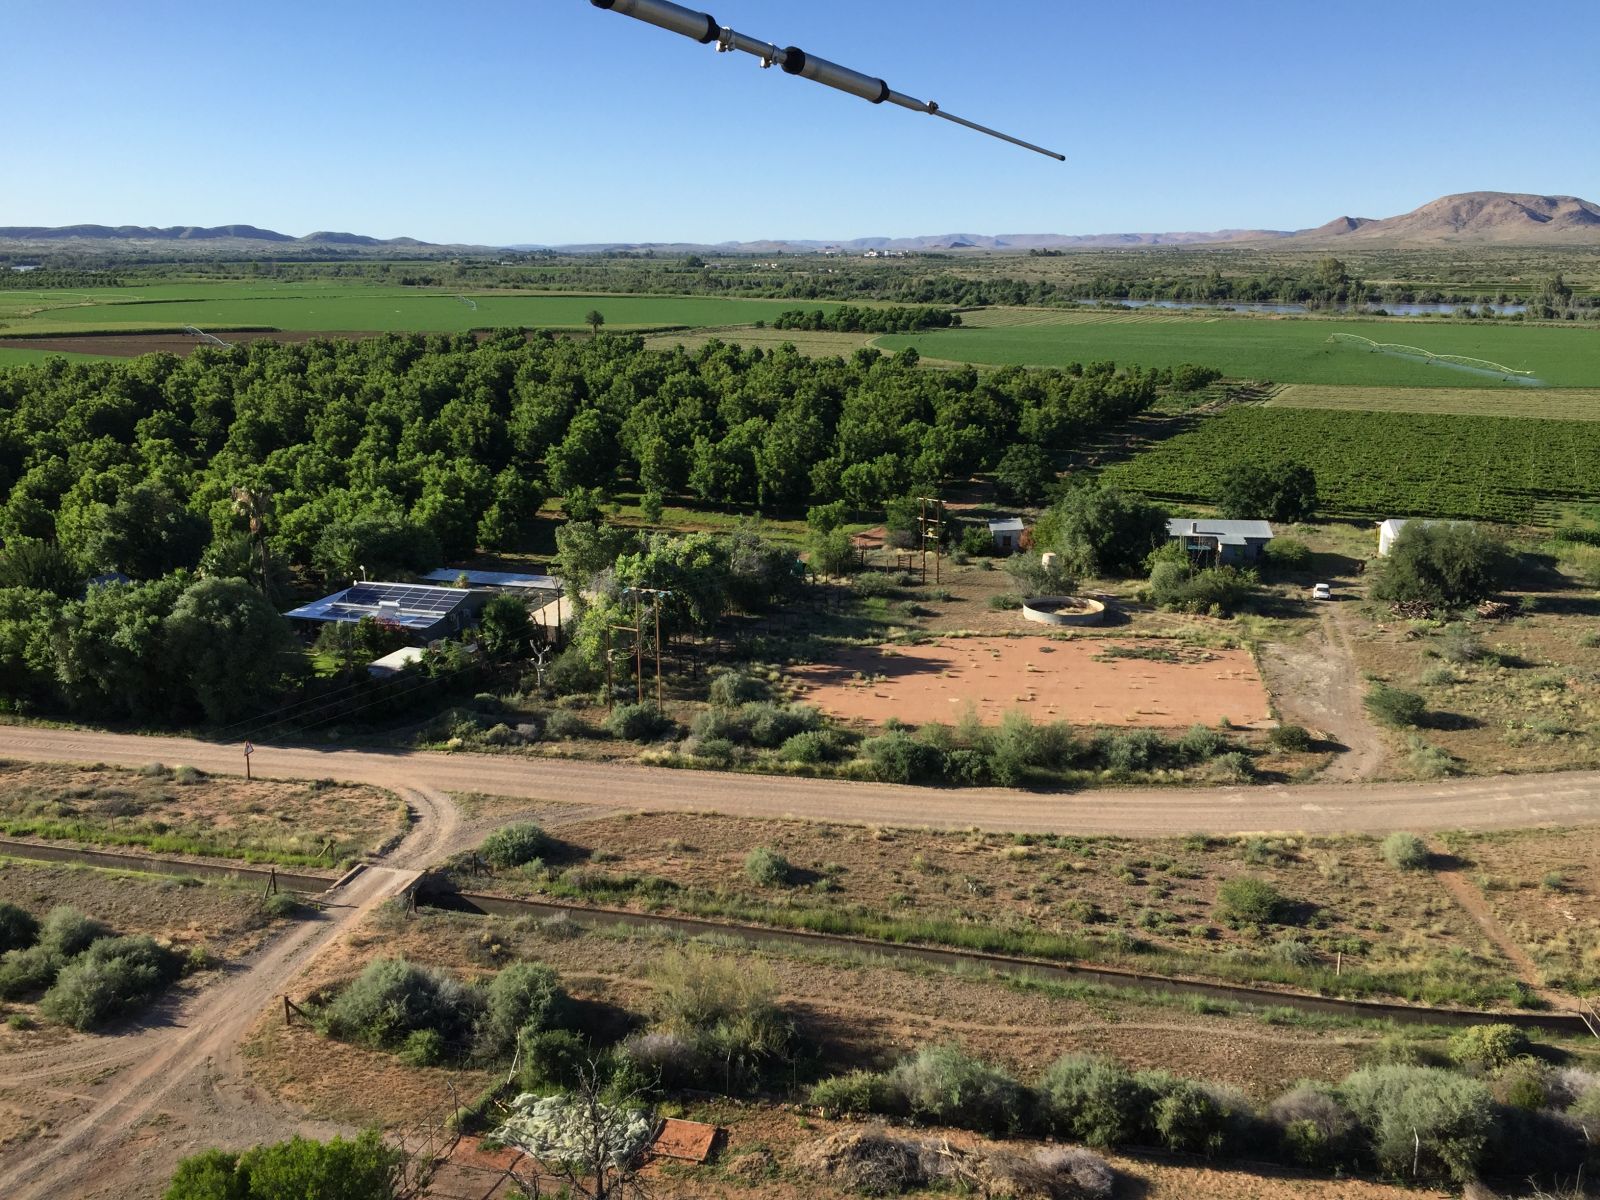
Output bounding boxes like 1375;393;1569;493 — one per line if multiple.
0;726;1600;838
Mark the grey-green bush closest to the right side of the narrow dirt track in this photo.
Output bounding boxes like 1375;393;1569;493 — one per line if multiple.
320;958;483;1048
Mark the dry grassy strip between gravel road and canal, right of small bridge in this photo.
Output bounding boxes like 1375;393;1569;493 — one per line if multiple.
448;813;1518;1003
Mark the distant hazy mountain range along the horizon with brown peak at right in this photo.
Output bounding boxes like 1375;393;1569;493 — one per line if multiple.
0;192;1600;258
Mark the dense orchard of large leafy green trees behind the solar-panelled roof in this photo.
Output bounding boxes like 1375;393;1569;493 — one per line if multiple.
0;334;1157;563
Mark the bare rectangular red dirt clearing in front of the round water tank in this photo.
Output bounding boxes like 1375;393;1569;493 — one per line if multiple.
794;637;1272;728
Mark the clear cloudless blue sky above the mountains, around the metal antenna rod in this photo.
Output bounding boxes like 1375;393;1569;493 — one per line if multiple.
12;0;1600;245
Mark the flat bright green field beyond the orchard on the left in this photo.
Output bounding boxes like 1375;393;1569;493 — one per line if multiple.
0;282;838;338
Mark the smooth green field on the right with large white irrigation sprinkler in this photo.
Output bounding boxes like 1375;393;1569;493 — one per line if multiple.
874;309;1600;389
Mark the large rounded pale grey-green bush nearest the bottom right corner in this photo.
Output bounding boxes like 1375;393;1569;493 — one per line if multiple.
1338;1066;1494;1184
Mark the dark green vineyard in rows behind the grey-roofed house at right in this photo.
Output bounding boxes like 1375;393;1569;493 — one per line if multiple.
1104;405;1600;525
